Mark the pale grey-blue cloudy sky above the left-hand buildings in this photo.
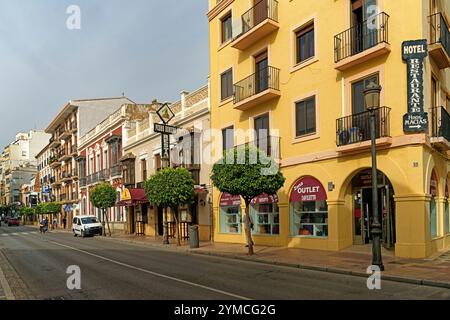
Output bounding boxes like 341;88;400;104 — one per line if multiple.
0;0;209;147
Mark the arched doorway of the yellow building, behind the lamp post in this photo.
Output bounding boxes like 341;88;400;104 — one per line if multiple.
351;169;396;249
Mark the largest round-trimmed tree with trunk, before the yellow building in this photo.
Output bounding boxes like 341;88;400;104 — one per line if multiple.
211;145;286;255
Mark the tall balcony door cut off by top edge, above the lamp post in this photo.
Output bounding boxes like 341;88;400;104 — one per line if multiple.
351;0;378;55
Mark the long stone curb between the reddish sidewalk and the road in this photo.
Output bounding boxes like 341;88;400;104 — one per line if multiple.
89;237;450;289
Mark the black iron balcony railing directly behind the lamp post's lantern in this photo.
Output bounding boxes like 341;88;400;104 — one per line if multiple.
336;107;391;147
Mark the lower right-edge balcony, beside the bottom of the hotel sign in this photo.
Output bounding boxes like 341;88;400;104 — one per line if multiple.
430;107;450;151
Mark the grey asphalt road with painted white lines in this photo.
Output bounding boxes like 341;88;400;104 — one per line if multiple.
0;225;450;300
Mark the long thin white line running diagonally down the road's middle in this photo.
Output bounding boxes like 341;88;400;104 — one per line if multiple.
48;240;251;300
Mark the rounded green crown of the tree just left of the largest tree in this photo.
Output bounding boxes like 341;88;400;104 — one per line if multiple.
144;168;195;210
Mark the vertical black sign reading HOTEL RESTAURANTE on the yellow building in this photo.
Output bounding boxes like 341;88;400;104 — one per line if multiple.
402;40;428;132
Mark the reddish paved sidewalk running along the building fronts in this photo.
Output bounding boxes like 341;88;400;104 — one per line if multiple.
98;234;450;289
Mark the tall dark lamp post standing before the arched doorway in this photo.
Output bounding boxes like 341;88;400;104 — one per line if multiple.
364;82;384;271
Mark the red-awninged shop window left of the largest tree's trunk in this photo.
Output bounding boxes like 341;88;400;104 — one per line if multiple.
220;193;242;234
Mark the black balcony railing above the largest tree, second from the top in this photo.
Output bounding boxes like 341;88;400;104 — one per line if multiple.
234;66;280;104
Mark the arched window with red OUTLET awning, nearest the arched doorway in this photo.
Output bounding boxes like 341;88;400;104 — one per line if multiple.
290;177;328;237
